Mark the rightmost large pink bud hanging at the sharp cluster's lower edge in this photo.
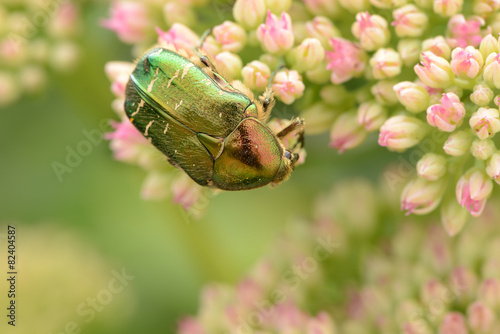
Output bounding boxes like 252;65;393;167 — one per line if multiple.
456;168;493;217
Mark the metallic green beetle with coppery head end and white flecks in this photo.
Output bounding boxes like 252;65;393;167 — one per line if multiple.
125;48;303;190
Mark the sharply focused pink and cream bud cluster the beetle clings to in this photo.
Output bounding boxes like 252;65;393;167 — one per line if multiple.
103;0;500;233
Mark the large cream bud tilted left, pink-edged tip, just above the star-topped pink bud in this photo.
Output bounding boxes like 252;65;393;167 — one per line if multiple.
414;51;454;88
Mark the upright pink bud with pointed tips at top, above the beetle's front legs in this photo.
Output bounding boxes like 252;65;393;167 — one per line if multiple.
257;10;294;54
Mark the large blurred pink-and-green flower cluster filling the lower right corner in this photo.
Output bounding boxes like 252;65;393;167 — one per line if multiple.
178;180;500;334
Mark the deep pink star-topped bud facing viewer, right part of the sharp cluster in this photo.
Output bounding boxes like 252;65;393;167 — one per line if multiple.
427;93;465;132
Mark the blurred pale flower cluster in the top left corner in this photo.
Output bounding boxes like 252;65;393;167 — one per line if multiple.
0;0;81;107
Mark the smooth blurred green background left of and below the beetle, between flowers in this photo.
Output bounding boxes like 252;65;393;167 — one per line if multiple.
0;3;395;334
